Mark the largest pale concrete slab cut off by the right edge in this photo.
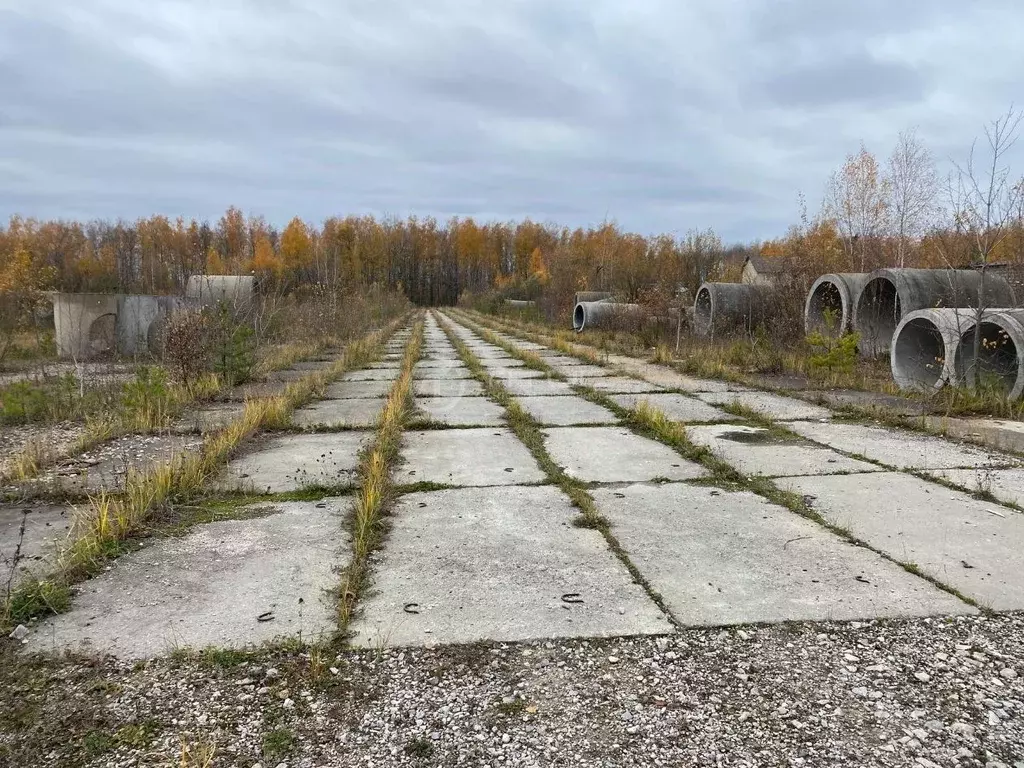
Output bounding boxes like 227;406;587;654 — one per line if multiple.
779;472;1024;610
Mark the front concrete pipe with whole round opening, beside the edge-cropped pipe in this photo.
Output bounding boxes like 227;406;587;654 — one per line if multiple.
889;309;977;391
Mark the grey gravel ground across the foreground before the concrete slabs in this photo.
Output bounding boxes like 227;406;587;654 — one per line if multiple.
0;614;1024;768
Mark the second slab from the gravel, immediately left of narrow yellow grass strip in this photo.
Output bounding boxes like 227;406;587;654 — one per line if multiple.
214;431;374;494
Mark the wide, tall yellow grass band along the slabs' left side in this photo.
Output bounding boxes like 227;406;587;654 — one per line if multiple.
0;318;403;627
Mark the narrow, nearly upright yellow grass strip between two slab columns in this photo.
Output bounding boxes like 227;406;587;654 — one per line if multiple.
338;319;423;635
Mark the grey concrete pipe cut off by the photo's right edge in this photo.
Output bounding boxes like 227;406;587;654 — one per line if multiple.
953;309;1024;399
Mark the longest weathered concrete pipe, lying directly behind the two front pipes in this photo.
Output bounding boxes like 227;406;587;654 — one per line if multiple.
853;269;1017;357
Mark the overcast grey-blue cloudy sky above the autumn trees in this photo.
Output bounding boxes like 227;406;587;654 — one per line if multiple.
0;0;1024;242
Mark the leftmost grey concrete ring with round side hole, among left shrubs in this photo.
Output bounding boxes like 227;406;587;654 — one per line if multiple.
53;293;118;360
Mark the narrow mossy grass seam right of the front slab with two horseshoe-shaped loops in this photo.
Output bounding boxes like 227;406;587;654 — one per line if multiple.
430;318;682;627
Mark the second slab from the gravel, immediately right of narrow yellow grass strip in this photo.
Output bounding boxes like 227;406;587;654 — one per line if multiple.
395;428;547;485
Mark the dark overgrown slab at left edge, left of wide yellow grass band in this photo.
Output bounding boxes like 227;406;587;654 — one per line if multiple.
0;502;75;586
